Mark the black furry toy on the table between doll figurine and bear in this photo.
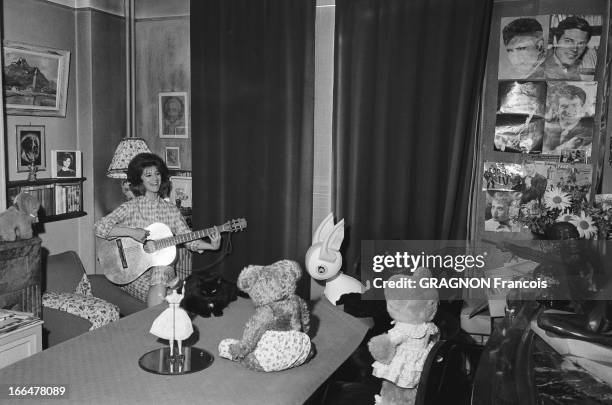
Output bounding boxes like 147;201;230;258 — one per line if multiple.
181;273;238;318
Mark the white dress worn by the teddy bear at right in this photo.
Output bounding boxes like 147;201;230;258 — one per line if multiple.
372;321;439;388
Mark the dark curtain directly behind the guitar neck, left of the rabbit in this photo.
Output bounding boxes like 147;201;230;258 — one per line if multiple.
191;0;315;296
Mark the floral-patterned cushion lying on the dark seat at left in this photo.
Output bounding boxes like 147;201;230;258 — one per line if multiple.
43;291;119;330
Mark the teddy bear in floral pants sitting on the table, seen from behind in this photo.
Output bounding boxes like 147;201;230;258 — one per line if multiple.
219;260;314;371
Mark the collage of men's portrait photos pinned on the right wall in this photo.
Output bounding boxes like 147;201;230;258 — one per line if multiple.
483;14;602;232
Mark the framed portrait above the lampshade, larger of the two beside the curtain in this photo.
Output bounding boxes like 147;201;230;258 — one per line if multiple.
159;91;189;138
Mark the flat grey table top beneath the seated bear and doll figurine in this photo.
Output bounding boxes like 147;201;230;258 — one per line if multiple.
0;298;367;405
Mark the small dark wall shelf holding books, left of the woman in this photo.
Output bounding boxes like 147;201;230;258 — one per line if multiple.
7;177;87;223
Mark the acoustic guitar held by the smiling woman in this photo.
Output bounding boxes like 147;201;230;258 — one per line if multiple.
97;218;247;284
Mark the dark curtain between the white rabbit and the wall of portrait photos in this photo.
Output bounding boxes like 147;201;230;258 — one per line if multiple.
333;0;493;274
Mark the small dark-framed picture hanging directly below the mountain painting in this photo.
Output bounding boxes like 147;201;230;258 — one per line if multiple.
15;125;47;172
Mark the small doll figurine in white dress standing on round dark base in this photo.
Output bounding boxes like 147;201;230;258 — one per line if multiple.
150;285;193;363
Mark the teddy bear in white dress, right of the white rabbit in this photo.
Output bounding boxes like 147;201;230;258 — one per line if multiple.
368;267;439;405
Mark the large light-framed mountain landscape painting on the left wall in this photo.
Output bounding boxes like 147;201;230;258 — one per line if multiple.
3;41;70;117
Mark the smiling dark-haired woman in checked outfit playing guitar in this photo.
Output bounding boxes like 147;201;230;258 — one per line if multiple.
94;153;221;306
